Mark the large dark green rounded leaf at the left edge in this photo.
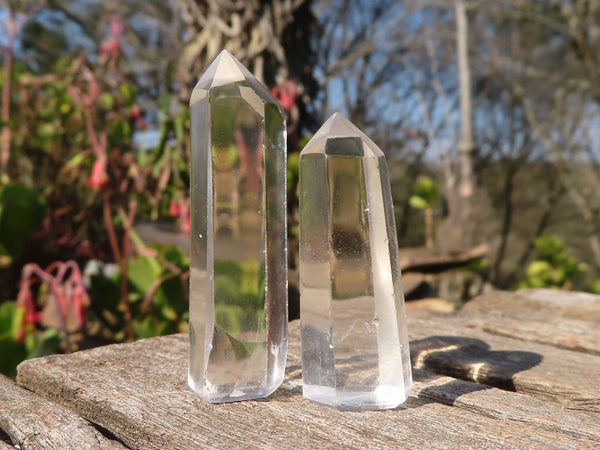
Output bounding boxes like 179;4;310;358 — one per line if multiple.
0;184;46;267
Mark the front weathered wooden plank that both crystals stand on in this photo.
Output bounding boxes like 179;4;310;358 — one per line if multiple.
18;322;600;448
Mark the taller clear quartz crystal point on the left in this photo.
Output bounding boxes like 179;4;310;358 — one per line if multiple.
188;51;287;403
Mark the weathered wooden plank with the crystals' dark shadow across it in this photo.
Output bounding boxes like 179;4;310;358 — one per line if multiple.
409;313;600;413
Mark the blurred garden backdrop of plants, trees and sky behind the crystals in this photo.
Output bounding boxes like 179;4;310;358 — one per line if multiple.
0;0;600;375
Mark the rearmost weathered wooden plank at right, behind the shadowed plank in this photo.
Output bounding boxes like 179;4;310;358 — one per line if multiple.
456;289;600;355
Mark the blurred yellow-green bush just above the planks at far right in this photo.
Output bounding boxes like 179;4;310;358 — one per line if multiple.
517;236;588;289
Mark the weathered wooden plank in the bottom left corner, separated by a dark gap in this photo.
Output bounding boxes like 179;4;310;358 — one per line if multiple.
0;375;125;449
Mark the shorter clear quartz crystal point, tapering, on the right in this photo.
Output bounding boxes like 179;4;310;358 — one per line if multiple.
300;114;412;410
